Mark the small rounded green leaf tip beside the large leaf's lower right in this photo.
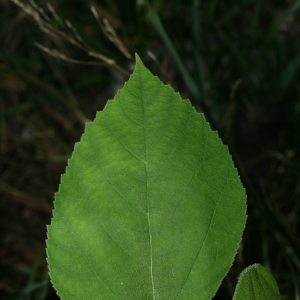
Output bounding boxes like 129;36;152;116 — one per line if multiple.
233;264;280;300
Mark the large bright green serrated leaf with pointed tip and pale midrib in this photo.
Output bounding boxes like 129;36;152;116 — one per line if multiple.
47;57;246;300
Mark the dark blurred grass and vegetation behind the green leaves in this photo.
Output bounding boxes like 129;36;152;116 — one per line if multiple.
0;0;300;300
